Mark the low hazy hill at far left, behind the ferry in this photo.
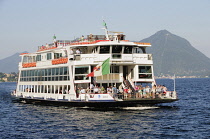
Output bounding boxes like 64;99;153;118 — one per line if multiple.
0;52;27;73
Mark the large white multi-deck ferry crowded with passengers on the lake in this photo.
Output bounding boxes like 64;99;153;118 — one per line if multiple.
12;22;178;107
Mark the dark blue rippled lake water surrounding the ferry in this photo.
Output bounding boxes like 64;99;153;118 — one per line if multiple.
0;78;210;139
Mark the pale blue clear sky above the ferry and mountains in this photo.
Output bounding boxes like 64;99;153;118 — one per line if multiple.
0;0;210;59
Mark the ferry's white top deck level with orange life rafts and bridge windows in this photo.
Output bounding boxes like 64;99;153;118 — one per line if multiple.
19;34;152;68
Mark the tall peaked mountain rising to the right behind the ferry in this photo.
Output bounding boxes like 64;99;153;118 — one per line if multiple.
141;30;210;76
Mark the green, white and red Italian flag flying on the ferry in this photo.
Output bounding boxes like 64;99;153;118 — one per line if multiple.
87;58;110;77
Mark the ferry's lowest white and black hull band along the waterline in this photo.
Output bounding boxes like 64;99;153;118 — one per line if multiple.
13;91;178;107
